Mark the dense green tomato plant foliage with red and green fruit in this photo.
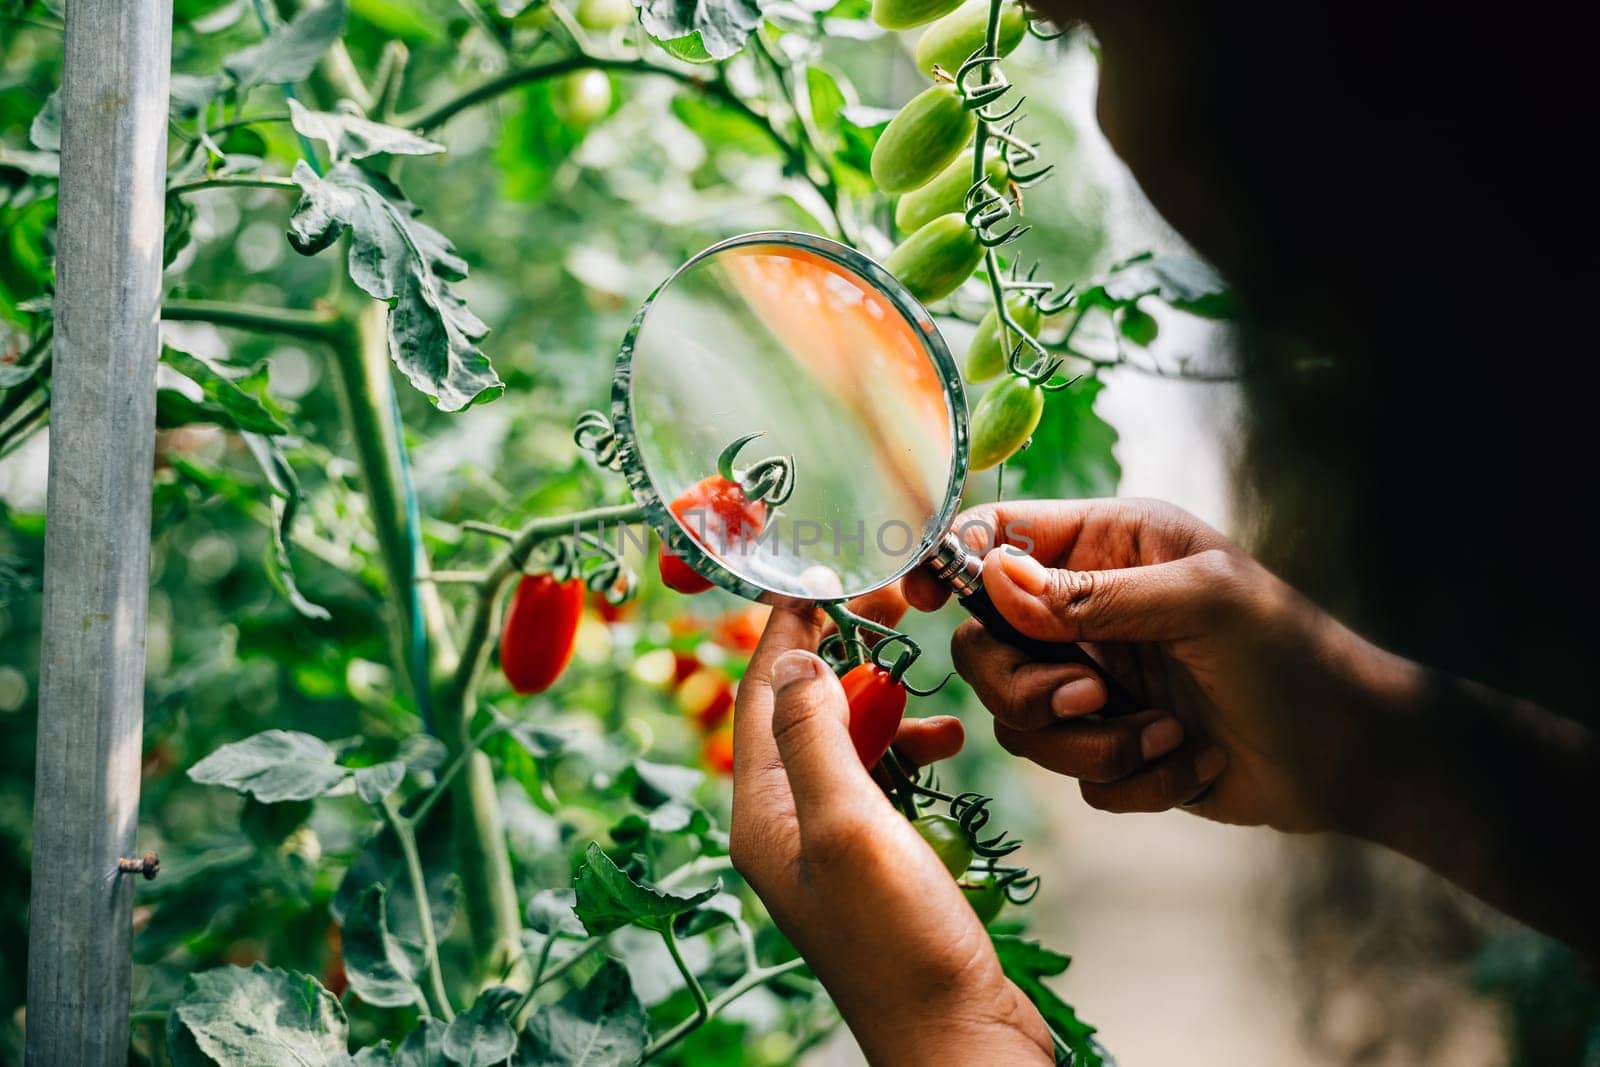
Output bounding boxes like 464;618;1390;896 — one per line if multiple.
0;0;1226;1064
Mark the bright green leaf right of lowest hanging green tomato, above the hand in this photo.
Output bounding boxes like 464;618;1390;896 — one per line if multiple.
1005;378;1122;499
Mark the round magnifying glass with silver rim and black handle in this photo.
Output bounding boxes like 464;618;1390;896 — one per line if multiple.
611;230;1133;712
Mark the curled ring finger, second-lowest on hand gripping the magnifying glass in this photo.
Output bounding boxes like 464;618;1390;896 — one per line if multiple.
995;710;1184;782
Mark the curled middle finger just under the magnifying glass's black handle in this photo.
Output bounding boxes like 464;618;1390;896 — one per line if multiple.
950;619;1107;729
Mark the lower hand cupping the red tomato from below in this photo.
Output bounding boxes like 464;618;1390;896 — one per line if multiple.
730;608;1054;1064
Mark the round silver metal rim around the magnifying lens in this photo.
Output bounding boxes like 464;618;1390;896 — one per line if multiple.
611;230;968;600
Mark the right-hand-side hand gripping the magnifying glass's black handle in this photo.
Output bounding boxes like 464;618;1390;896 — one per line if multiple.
904;501;1414;830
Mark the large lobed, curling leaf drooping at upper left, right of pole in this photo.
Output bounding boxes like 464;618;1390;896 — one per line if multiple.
290;160;506;411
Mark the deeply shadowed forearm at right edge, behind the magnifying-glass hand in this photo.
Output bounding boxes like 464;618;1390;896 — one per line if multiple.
1350;669;1600;955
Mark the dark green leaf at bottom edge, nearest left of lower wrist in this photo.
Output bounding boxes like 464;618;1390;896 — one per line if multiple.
515;960;648;1067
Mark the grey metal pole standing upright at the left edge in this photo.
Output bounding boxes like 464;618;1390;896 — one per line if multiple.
27;0;173;1067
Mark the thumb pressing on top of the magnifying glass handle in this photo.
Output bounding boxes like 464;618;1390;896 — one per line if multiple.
984;549;1232;641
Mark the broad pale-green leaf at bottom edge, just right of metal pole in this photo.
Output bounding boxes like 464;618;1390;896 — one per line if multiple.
166;963;350;1067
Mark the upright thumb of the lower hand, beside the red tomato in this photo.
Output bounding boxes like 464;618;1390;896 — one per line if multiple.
773;649;882;827
